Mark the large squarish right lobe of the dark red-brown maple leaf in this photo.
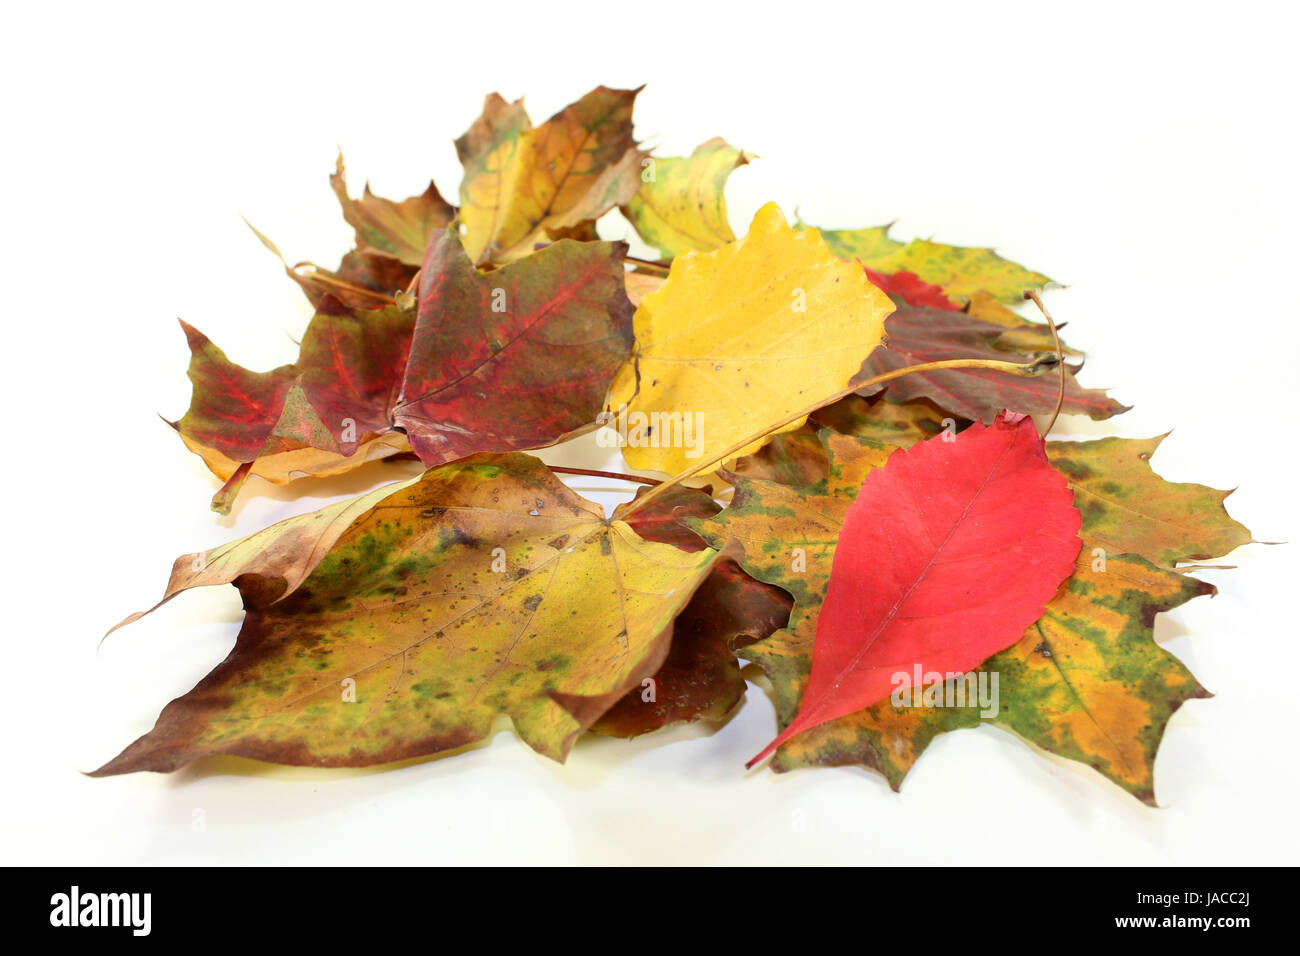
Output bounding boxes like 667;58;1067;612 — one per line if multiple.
393;230;632;467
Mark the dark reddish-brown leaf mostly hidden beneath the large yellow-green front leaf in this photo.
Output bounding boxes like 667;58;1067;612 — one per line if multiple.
592;486;790;737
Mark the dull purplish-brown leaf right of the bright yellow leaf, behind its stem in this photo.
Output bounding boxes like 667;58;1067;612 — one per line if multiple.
862;307;1127;421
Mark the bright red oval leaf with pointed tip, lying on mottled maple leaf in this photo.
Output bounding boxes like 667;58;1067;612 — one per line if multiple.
749;412;1082;766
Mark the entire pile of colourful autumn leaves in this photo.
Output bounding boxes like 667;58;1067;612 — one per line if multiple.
96;87;1251;803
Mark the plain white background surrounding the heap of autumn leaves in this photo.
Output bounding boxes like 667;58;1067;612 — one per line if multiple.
0;3;1300;865
